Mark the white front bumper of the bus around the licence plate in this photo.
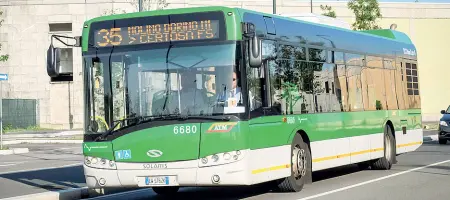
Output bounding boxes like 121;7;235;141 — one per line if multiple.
84;151;251;188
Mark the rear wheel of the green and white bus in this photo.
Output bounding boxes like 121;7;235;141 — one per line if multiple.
371;125;396;170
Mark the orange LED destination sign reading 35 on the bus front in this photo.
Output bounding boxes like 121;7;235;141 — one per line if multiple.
94;20;220;47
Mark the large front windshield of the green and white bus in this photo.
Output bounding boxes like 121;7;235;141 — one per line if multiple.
84;43;245;132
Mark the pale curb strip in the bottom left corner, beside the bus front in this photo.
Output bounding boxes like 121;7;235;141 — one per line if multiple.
2;187;88;200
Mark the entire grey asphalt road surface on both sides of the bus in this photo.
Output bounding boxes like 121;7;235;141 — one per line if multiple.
0;131;442;200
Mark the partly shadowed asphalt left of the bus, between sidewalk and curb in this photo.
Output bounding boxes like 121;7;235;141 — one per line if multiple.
0;144;86;199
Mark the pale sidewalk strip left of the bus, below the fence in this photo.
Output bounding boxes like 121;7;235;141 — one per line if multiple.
3;130;83;145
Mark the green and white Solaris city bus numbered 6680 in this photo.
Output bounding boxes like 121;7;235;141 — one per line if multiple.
47;7;423;194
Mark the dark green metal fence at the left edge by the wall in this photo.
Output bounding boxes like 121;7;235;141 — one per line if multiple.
2;99;38;128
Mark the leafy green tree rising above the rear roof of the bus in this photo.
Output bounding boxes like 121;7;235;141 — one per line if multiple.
347;0;382;30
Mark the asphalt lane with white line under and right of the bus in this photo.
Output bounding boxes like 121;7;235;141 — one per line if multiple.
85;131;450;200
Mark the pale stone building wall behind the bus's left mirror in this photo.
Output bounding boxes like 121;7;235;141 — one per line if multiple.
0;0;132;129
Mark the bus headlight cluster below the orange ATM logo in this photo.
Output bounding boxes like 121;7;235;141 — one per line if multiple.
199;150;245;167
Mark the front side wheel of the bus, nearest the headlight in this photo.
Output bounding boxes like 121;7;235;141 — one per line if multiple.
277;134;312;192
